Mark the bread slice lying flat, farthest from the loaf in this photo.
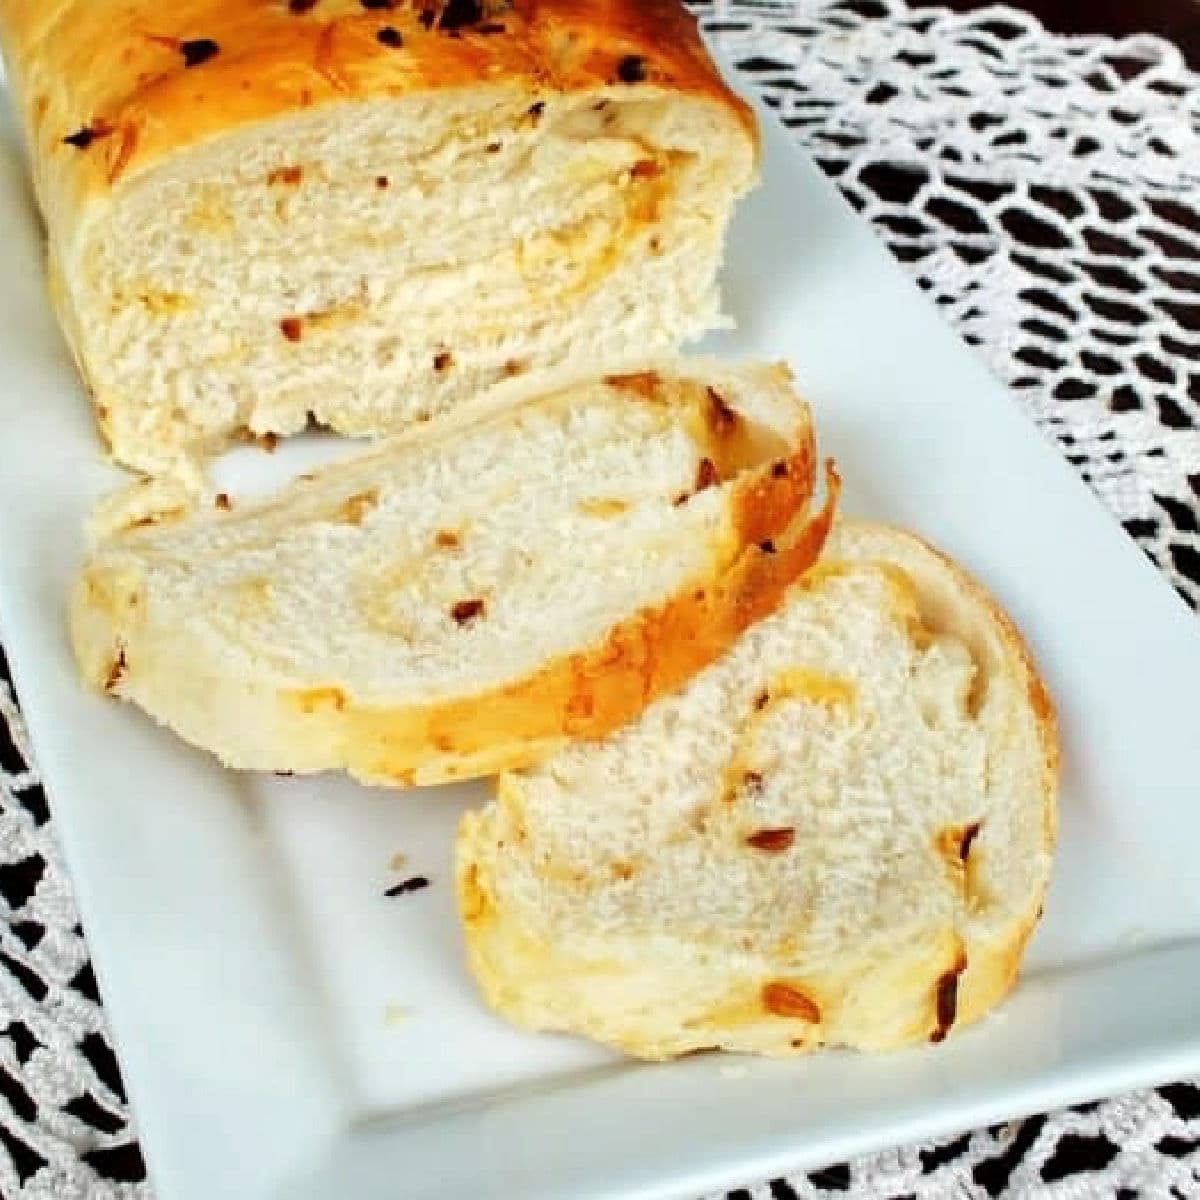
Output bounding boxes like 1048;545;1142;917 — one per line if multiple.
457;522;1057;1058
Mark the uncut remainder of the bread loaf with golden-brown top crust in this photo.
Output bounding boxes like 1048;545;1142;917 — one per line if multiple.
0;0;757;473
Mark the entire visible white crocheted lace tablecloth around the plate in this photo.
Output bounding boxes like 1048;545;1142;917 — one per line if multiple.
0;0;1200;1200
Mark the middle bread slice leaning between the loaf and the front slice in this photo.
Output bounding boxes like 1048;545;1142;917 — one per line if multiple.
71;361;836;785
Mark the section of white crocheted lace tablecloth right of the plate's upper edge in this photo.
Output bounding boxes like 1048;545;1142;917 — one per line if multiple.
701;0;1200;607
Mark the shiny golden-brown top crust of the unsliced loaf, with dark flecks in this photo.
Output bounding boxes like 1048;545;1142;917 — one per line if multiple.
0;0;755;206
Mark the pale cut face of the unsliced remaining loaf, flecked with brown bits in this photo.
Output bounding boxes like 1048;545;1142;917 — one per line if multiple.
58;82;754;472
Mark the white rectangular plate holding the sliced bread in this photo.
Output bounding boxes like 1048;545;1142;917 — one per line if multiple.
0;72;1200;1200
